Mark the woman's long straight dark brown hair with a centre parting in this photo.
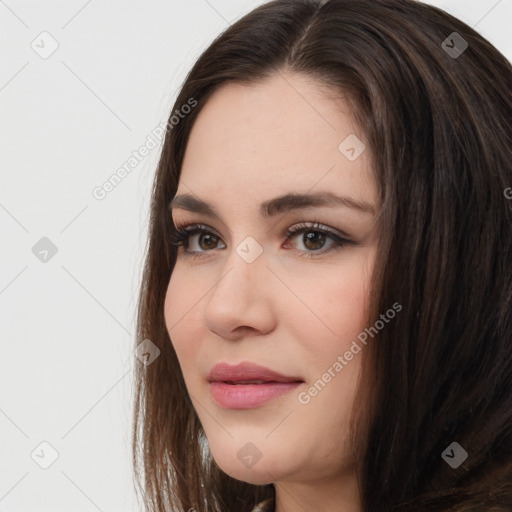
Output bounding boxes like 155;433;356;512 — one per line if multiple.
132;0;512;512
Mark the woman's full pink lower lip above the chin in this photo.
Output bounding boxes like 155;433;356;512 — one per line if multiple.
210;382;302;409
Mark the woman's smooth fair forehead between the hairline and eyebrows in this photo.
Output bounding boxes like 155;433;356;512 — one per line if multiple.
178;74;377;209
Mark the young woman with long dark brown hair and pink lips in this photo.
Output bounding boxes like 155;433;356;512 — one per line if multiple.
133;0;512;512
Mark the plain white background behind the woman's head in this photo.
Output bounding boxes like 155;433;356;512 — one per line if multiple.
0;0;512;512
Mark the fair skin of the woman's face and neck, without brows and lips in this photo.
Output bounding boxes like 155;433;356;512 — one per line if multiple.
165;73;379;512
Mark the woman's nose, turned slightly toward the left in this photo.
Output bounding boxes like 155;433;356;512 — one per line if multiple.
204;244;277;340
